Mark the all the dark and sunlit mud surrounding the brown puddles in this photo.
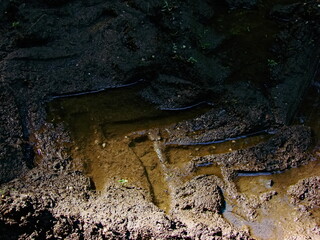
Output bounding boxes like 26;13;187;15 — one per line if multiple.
0;0;320;239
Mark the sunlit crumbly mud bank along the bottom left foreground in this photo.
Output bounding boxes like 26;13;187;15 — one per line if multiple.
1;123;249;239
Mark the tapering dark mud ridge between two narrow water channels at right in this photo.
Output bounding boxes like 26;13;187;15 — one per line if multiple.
195;126;311;172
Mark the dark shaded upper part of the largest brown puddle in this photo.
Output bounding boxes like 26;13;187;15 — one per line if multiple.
48;86;209;141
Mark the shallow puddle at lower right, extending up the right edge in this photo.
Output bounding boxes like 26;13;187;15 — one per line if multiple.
231;80;320;239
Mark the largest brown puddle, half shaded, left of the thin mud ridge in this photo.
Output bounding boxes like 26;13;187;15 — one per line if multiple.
48;86;214;211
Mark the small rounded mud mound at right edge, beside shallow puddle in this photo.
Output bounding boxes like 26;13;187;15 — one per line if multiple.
288;176;320;210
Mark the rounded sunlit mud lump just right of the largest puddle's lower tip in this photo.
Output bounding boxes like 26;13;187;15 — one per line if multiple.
173;176;224;213
